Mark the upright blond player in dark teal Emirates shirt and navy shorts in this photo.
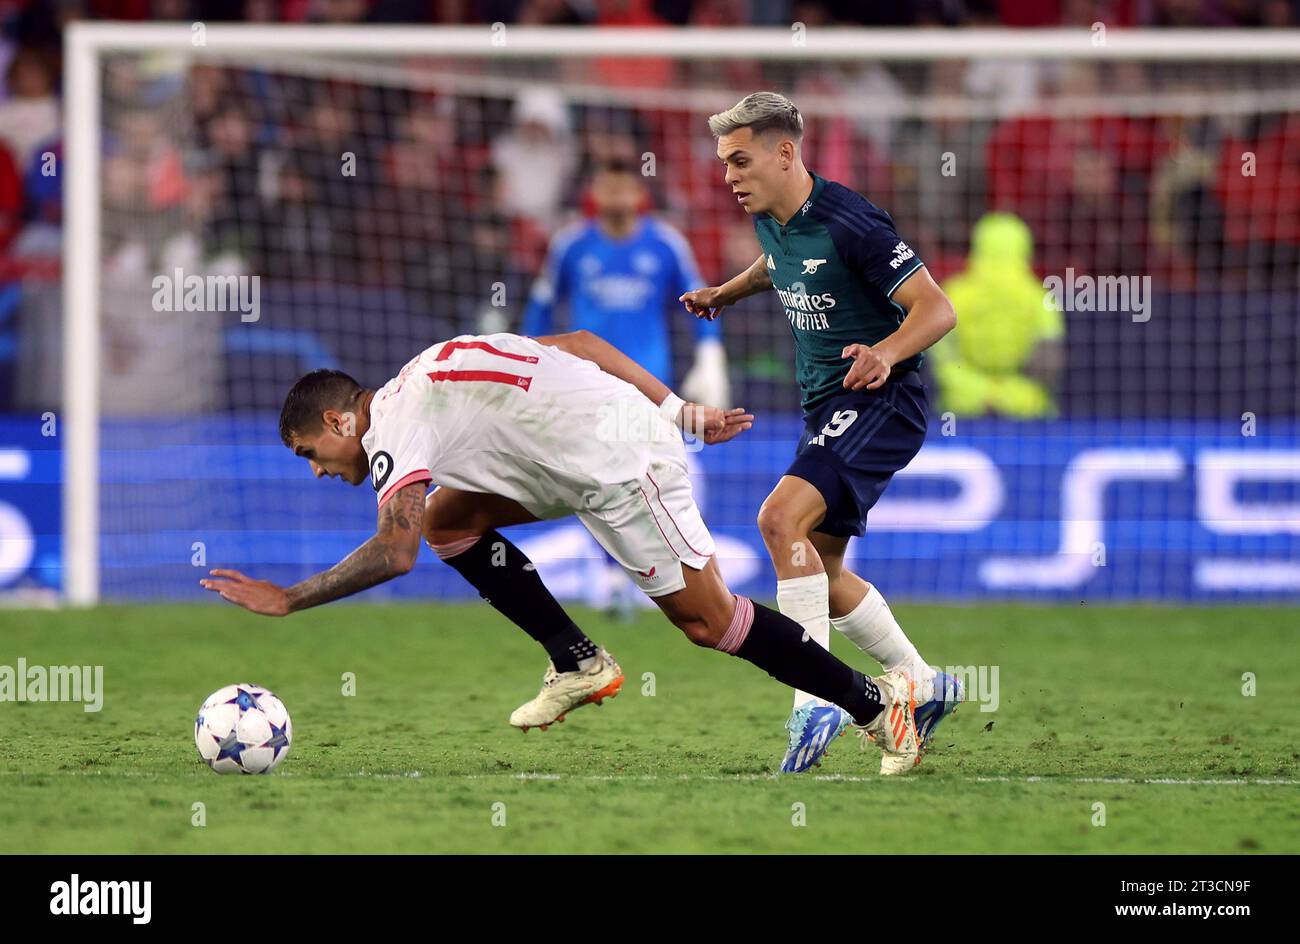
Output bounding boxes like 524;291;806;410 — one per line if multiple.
681;92;962;772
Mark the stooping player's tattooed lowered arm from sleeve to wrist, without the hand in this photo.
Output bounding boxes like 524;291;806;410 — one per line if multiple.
286;482;424;611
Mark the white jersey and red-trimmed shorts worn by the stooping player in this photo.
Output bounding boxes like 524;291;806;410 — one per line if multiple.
361;334;717;597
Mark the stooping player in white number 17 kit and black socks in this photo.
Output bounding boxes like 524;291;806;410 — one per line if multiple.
202;332;919;774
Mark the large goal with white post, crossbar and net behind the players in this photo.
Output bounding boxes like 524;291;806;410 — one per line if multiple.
48;23;1300;602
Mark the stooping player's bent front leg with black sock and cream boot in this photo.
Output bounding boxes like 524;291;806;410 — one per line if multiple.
423;488;623;731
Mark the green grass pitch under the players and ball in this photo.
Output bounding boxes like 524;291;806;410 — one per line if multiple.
0;603;1300;853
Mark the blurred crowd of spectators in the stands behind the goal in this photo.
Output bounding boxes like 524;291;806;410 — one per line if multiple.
0;0;1300;413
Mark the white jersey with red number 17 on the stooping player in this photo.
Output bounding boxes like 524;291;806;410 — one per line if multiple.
361;334;685;519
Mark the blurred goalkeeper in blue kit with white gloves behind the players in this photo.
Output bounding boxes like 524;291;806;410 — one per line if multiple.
523;156;731;615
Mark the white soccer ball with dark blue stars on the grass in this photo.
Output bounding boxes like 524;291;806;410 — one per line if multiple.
194;685;294;774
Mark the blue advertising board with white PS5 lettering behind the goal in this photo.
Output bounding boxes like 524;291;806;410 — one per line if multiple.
0;413;1300;601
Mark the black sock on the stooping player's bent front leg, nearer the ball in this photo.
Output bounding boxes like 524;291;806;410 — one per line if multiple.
438;531;597;672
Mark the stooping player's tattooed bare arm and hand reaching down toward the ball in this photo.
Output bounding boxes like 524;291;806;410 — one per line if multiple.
199;481;428;616
